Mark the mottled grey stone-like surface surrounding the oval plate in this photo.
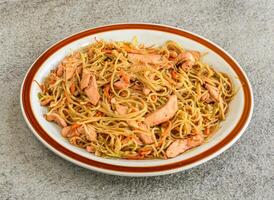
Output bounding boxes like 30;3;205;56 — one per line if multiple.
0;0;274;200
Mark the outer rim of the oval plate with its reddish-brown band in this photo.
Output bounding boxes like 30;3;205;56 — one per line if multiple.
20;23;254;176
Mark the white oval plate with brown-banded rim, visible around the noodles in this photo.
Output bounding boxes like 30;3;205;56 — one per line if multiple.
20;24;253;176
